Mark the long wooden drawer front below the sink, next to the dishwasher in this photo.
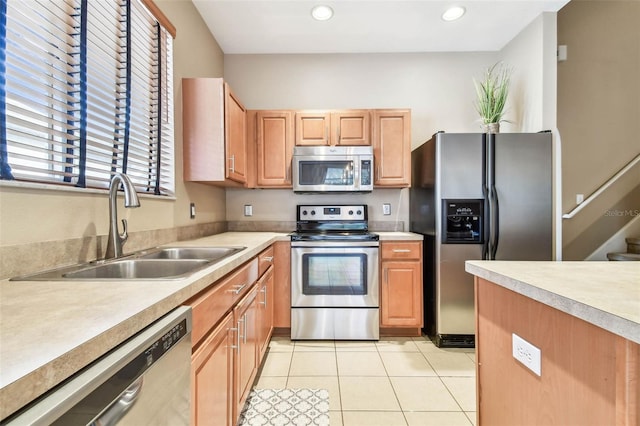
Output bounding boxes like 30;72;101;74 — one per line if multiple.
189;258;258;347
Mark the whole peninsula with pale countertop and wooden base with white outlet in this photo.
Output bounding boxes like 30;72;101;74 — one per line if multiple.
466;261;640;425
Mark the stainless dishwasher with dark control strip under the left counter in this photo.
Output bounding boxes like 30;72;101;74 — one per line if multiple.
2;306;191;426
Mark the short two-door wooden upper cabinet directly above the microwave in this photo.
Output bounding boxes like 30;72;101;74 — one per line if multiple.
295;110;371;146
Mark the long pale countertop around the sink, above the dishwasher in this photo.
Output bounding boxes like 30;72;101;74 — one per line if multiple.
0;232;289;419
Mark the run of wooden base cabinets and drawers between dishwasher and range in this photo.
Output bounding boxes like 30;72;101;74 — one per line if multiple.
188;247;276;426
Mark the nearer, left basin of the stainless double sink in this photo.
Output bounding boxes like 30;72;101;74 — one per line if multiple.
62;259;210;280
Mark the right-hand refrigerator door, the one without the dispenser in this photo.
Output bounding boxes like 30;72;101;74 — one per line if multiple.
491;133;553;260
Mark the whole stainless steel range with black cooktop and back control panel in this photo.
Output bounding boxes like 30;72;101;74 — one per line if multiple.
291;204;380;340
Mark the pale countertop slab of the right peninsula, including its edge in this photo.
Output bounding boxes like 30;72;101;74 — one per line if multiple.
465;260;640;344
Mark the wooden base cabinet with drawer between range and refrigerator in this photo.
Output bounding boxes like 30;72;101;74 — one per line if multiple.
380;241;423;328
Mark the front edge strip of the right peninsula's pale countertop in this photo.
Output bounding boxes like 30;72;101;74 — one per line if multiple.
465;261;640;344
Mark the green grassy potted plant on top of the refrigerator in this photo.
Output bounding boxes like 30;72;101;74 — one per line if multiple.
473;62;511;133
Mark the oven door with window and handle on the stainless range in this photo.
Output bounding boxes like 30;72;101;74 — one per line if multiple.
291;241;379;308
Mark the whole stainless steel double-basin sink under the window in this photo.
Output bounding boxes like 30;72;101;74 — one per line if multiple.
11;247;246;281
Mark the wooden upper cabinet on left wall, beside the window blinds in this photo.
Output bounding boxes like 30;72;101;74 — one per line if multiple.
182;78;247;186
